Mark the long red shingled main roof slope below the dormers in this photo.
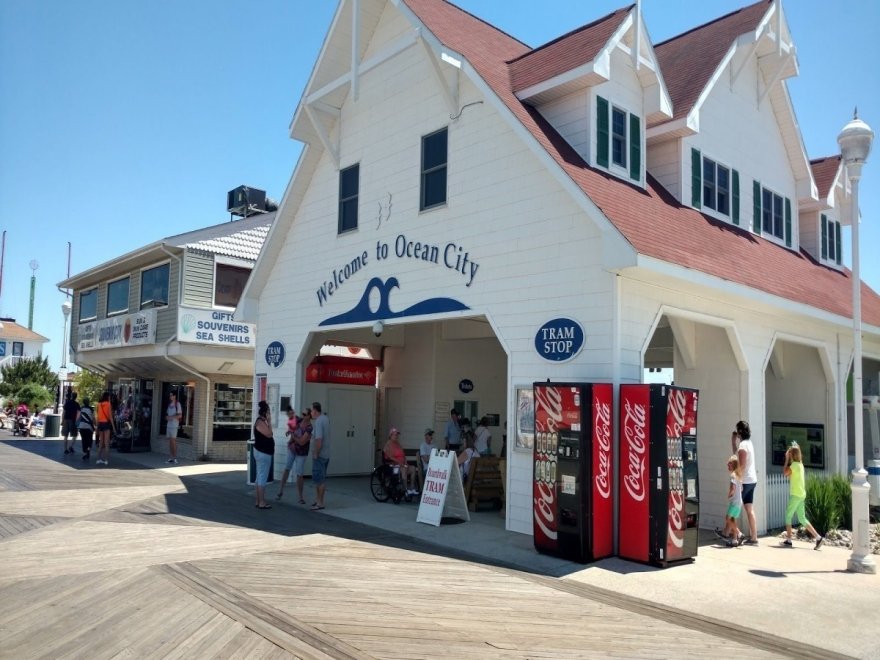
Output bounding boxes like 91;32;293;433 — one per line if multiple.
404;0;880;325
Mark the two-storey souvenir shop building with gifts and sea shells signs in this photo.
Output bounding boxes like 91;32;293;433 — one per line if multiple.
59;213;274;460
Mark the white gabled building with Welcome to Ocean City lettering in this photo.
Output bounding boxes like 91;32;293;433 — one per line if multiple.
237;0;880;533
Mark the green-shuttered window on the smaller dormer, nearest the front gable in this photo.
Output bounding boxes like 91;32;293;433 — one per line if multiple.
596;96;642;182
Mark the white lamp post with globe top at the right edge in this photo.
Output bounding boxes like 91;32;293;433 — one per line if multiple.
837;112;877;573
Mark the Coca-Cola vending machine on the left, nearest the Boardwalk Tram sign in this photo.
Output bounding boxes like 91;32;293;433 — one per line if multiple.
534;383;614;562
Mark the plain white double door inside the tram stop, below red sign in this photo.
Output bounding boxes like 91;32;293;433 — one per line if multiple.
327;389;376;475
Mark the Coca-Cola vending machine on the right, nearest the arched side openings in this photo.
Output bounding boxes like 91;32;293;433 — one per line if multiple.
617;384;700;566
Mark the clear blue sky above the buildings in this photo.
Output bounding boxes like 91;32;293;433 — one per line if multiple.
0;0;880;367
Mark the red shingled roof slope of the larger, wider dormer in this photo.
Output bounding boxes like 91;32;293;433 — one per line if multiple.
654;0;773;119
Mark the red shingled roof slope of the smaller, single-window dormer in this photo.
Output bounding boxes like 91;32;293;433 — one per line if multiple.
510;5;635;92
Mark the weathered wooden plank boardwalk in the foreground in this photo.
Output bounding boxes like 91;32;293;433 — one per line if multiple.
0;440;834;660
